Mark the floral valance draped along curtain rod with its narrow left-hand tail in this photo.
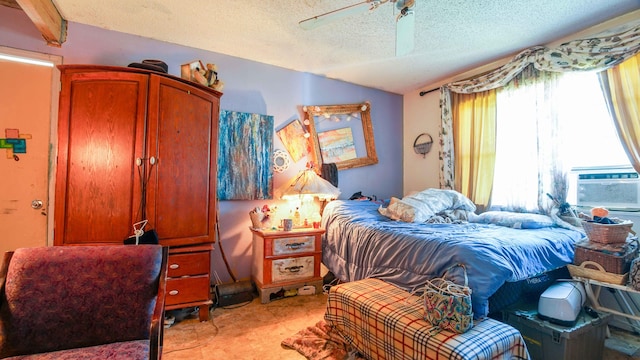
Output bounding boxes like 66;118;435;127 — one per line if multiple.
440;21;640;202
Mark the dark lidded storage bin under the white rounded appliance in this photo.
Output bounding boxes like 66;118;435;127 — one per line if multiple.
502;304;611;360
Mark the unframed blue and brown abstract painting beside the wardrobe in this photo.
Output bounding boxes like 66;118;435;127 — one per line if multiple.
217;110;273;200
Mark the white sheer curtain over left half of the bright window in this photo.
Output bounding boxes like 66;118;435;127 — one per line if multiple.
491;66;566;212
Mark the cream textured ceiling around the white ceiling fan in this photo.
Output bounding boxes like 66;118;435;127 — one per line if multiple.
54;0;640;94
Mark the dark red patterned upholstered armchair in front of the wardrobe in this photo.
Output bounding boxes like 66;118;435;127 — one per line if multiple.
0;245;167;360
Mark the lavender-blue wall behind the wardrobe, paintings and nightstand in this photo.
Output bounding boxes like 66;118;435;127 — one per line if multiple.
0;6;403;282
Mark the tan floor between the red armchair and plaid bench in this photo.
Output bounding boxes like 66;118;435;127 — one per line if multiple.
162;294;327;360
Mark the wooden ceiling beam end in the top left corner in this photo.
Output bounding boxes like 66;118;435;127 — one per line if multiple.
16;0;67;47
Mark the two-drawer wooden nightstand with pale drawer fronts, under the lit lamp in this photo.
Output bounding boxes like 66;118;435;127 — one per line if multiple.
251;228;325;304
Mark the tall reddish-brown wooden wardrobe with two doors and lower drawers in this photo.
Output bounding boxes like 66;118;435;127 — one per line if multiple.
54;65;222;320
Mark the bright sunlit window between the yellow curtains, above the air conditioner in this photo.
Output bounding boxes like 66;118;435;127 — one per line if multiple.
492;72;630;211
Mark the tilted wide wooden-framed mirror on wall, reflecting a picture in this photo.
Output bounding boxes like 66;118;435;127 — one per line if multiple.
302;102;378;170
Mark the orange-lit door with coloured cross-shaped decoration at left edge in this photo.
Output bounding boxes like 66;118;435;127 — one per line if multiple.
0;47;61;254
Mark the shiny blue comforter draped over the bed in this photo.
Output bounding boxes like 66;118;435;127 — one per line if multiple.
322;200;584;318
